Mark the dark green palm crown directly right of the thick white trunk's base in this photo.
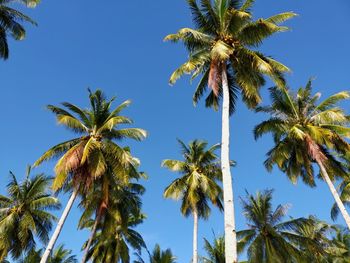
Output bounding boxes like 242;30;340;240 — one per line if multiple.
237;190;307;263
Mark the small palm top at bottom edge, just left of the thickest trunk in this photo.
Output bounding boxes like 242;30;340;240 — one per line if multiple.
202;236;225;263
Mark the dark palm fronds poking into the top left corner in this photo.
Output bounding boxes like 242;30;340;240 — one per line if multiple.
0;0;40;59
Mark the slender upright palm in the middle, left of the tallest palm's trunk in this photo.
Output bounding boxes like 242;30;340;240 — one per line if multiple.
162;140;222;263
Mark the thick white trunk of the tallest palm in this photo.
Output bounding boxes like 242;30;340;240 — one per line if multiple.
221;64;238;263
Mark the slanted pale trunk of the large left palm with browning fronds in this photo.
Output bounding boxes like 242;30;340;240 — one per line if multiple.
40;190;78;263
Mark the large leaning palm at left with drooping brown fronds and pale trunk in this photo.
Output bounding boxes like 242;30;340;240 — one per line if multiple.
34;90;146;263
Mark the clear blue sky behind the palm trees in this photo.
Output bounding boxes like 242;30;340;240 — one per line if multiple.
0;0;350;263
